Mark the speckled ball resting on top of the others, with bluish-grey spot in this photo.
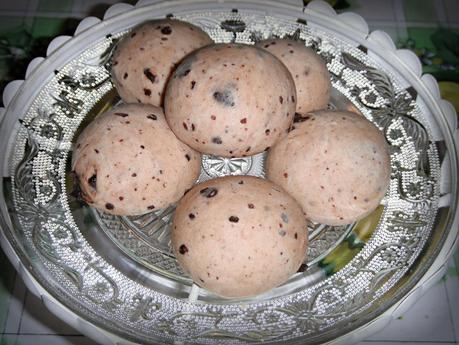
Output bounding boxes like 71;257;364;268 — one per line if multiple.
164;44;296;157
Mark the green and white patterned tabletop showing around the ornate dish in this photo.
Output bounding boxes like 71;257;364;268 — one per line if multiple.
0;0;459;345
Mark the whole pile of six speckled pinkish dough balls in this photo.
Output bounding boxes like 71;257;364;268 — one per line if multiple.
72;19;390;297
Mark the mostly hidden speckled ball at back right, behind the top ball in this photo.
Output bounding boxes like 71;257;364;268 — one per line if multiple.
256;39;331;114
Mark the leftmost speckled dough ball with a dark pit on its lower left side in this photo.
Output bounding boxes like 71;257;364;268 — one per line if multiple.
72;104;201;215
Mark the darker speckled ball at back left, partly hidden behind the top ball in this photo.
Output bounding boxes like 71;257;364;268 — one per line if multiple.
112;19;213;106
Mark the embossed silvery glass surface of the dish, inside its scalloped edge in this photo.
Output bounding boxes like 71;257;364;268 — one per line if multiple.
2;4;449;344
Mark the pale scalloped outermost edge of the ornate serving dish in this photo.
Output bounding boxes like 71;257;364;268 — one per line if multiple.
0;0;459;345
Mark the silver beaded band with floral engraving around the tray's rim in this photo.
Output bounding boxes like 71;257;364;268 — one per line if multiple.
6;10;439;344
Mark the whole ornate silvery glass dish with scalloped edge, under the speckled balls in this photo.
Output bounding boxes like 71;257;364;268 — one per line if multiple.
0;0;459;344
